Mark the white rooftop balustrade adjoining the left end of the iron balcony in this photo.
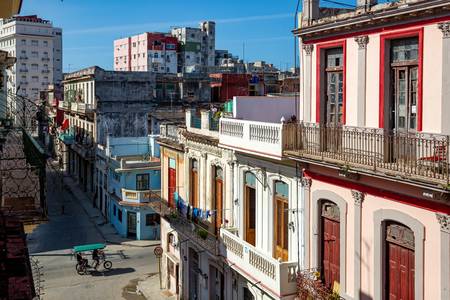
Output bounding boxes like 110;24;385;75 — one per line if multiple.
219;118;283;159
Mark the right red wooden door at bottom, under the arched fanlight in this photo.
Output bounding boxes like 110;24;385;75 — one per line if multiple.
386;242;414;300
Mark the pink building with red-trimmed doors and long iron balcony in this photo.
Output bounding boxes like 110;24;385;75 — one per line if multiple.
290;0;450;300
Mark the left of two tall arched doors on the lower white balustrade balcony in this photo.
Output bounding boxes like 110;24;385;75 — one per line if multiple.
244;172;256;246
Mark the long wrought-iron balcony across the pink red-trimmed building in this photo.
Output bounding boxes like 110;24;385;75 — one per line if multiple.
283;123;450;187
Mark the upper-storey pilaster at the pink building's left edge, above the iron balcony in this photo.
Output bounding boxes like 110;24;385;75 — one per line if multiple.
300;44;312;122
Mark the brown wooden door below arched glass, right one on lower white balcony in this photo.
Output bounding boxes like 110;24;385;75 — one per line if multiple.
274;196;289;261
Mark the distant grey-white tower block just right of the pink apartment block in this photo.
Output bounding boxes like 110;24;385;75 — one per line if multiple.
172;21;216;72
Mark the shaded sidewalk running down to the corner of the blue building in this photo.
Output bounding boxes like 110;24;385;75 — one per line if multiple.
64;176;160;247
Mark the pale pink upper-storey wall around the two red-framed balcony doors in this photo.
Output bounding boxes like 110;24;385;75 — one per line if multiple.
301;23;444;133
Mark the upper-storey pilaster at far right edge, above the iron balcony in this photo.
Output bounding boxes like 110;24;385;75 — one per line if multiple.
438;22;450;134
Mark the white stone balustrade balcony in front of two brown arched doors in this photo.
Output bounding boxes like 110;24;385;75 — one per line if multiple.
220;228;297;298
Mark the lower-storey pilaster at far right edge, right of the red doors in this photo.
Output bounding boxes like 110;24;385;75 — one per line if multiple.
436;213;450;300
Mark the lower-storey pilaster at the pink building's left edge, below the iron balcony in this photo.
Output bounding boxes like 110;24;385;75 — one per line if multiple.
300;177;312;269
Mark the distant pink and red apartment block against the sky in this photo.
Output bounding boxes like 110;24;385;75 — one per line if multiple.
114;32;178;74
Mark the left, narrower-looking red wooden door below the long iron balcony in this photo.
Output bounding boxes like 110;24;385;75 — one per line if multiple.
322;217;340;288
